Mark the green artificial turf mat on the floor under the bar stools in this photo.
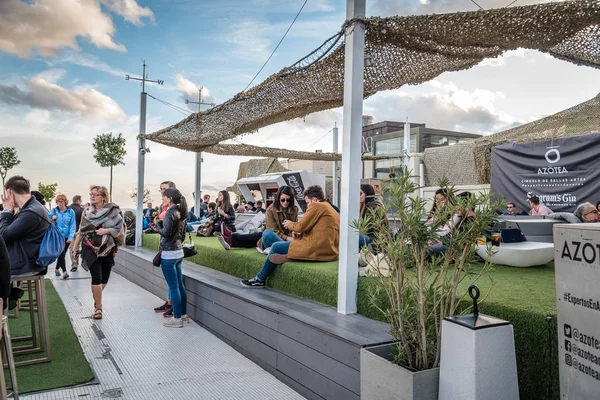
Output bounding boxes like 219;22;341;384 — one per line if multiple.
5;280;94;393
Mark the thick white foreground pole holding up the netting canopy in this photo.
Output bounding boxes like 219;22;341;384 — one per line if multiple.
337;0;365;314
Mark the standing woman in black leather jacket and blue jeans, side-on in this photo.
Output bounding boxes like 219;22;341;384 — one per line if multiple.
156;189;189;328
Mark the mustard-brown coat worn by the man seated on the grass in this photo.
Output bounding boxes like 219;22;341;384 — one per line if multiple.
288;202;340;261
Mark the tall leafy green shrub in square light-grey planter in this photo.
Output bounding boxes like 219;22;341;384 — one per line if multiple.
354;173;499;400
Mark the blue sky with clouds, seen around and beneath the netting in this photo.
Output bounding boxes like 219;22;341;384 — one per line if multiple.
0;0;600;207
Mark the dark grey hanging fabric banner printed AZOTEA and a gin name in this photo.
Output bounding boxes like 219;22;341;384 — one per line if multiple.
491;133;600;212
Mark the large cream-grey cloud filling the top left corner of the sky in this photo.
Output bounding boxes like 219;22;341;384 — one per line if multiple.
0;0;153;57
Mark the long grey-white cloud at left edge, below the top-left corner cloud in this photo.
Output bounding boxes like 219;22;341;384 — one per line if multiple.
0;77;125;120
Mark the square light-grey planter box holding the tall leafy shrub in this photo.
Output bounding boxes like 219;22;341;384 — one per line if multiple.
360;344;440;400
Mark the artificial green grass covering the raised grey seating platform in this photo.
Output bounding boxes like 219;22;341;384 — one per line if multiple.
143;234;559;399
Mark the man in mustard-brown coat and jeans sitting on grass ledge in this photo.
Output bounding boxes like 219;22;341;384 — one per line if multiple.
240;185;340;288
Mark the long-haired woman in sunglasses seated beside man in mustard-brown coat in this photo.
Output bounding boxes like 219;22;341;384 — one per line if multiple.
215;186;298;254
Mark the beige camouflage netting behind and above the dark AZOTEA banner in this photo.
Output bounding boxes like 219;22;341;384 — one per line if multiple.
423;94;600;186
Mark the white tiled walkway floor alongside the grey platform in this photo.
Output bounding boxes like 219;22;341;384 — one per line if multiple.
21;269;303;400
